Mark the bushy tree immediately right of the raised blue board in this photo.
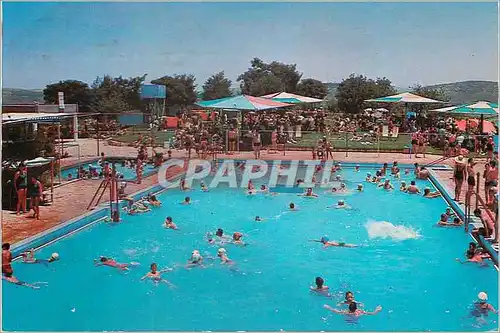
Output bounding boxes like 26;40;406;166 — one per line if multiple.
151;74;196;107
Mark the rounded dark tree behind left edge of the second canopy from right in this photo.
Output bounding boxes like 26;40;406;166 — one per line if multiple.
335;74;396;113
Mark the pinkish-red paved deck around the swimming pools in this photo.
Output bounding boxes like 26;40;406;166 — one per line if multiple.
2;137;492;243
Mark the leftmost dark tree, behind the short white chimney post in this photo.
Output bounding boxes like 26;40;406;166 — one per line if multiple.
43;80;92;112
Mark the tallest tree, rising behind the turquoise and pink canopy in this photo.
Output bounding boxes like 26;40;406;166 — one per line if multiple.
237;58;302;96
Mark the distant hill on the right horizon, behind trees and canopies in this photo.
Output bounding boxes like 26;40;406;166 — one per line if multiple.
325;81;498;104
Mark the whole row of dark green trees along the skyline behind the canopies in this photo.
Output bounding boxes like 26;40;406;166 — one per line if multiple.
43;58;446;113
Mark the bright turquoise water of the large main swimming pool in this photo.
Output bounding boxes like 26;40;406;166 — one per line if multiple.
2;165;498;331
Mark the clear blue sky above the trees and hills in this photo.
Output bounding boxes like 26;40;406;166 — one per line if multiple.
2;2;498;89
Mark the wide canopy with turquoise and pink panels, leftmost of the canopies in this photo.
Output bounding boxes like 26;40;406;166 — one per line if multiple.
196;95;291;111
